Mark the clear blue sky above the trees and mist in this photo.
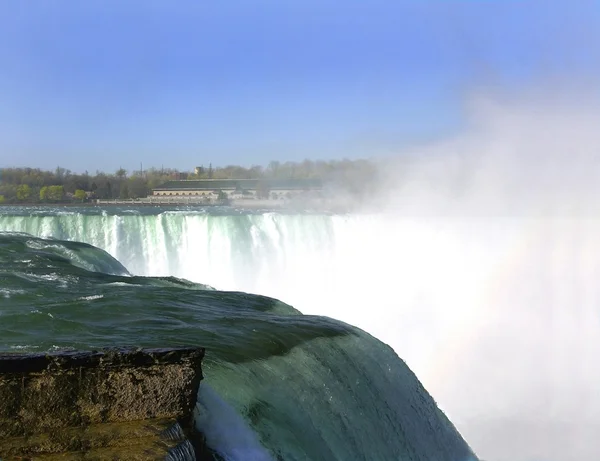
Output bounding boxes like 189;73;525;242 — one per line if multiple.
0;0;600;172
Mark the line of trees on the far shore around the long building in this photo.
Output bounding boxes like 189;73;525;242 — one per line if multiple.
0;160;378;204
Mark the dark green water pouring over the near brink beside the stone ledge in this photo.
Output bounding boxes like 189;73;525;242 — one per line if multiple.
0;233;475;461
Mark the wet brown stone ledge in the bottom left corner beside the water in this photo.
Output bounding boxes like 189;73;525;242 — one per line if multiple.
0;348;204;460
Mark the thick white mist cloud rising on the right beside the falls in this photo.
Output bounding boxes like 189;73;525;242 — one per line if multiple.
360;87;600;461
